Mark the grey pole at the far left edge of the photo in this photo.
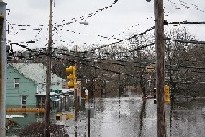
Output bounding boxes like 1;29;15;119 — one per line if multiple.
0;0;7;137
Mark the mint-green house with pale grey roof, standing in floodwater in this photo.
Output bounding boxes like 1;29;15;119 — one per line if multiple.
6;63;62;107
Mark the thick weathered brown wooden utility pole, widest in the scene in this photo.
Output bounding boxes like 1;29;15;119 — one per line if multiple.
154;0;166;137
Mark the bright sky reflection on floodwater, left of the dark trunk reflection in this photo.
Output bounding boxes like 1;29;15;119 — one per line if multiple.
91;97;141;137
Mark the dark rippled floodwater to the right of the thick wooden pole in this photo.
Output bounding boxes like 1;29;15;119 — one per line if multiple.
171;99;205;137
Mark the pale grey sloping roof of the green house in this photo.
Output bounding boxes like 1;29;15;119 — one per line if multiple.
8;63;62;83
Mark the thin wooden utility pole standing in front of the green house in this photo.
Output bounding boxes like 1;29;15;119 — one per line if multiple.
44;0;53;137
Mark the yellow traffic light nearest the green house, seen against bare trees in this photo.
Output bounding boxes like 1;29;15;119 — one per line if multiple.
66;66;77;88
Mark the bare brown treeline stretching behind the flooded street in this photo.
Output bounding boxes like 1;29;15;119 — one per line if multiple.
8;28;205;96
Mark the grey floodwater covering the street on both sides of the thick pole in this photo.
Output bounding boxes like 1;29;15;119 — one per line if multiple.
6;96;205;137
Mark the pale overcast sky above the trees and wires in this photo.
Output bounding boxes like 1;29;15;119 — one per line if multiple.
3;0;205;49
